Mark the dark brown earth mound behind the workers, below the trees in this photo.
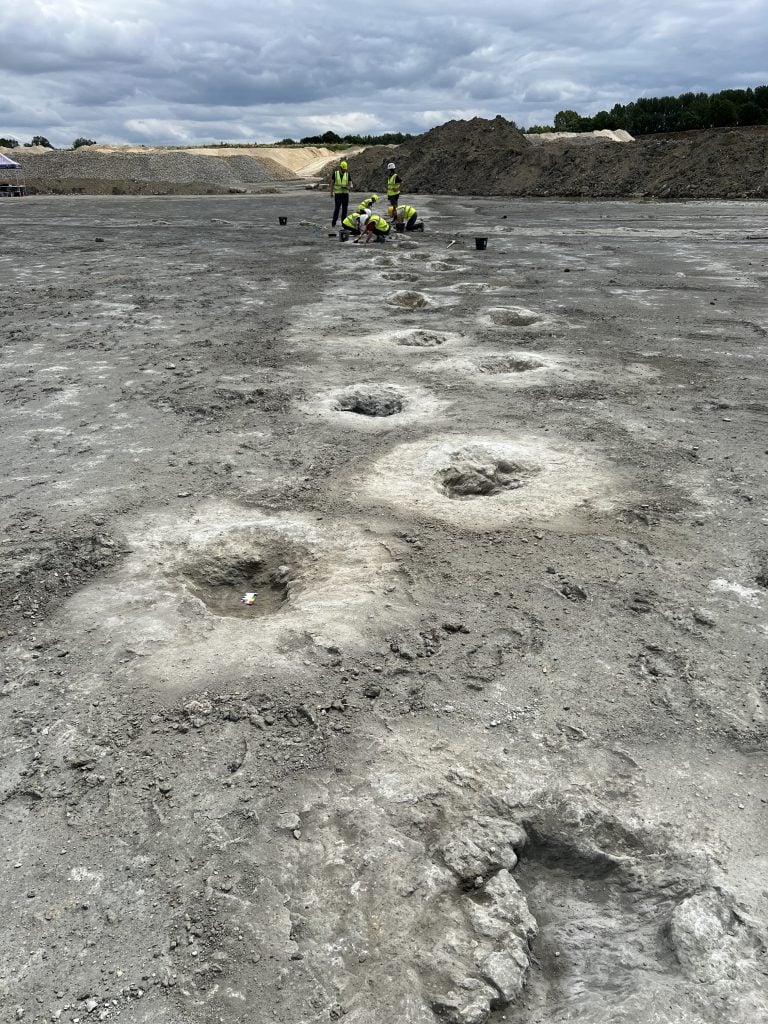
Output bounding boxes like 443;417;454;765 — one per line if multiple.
350;117;768;199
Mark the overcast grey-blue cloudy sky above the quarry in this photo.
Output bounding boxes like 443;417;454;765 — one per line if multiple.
0;0;768;146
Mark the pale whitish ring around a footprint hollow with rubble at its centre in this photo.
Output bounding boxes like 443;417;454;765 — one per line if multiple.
366;435;617;528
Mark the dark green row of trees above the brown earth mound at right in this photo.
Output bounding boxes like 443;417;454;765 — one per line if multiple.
527;85;768;135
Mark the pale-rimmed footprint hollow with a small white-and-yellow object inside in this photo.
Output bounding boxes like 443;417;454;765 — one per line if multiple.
60;502;407;690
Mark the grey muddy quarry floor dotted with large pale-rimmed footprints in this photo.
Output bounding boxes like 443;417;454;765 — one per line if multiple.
0;194;768;1024
